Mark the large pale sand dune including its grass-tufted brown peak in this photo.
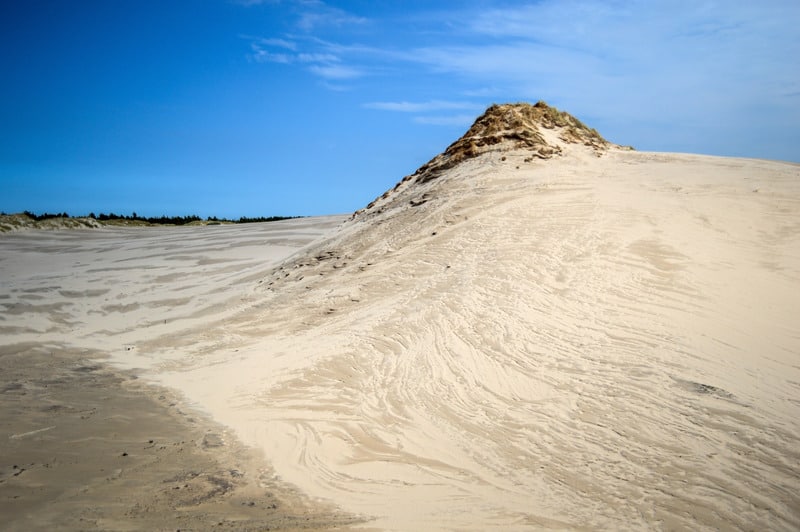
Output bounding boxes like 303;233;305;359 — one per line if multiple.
152;106;800;530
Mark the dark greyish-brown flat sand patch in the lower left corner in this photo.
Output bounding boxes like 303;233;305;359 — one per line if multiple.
0;344;354;531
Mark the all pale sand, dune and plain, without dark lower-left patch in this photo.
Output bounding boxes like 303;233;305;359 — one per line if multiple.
0;139;800;530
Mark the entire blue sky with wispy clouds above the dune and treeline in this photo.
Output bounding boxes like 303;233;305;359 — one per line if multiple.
0;0;800;217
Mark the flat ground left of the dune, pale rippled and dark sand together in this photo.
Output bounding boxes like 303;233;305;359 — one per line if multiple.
0;217;358;531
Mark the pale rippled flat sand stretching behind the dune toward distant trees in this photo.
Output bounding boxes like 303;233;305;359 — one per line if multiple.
0;216;344;365
